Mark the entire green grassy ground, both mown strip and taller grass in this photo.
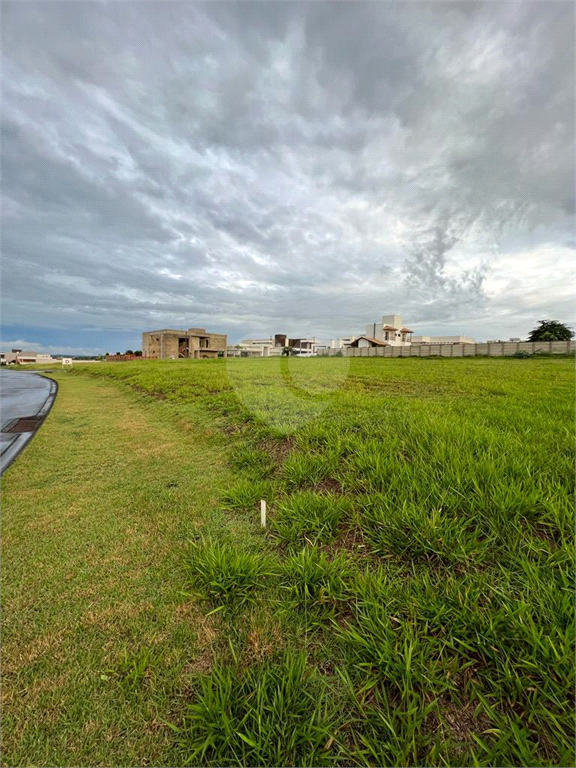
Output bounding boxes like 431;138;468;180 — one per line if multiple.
3;358;574;766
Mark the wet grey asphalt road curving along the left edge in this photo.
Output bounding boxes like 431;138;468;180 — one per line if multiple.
0;369;57;474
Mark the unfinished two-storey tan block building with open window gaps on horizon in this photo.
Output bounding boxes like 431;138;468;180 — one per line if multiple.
142;328;228;360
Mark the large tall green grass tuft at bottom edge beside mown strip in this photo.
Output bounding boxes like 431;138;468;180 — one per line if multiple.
178;652;339;766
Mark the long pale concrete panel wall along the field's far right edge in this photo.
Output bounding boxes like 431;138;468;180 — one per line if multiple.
325;339;576;357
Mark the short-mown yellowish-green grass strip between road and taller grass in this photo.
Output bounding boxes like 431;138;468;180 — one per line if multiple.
2;373;245;766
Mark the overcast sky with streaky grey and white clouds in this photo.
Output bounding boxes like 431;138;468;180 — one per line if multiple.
1;0;575;353
